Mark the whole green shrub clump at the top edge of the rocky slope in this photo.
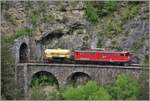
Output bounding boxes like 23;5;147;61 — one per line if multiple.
85;0;117;24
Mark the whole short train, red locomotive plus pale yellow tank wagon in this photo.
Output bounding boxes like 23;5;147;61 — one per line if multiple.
44;49;132;65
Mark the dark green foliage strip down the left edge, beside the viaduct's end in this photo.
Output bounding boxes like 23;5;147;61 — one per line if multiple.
1;36;23;100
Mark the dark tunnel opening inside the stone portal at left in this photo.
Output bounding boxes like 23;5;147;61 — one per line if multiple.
19;43;28;63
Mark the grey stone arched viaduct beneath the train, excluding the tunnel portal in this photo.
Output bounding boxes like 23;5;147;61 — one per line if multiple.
16;63;148;92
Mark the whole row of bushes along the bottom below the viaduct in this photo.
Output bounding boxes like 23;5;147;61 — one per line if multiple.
27;74;140;100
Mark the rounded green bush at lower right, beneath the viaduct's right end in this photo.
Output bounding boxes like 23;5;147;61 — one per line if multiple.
108;74;140;100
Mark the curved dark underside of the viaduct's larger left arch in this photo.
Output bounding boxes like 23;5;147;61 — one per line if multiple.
28;71;59;88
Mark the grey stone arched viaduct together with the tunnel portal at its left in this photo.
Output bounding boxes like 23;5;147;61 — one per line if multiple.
12;37;149;93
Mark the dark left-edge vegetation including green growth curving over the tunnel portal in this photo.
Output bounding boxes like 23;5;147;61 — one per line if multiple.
1;26;32;100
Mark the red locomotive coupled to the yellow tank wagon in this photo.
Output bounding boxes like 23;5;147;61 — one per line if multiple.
74;50;131;65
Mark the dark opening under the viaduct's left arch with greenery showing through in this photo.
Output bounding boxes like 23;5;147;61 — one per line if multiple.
29;71;59;88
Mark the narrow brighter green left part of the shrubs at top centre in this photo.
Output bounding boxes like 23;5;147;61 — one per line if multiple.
85;2;98;24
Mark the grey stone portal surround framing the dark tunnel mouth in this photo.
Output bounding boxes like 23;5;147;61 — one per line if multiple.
12;37;30;63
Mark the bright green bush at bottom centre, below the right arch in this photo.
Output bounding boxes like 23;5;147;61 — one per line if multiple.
63;81;111;100
